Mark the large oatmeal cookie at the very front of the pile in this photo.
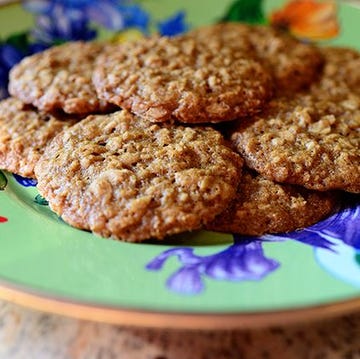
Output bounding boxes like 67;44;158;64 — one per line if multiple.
35;110;243;242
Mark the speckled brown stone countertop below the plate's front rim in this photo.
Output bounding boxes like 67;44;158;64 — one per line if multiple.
0;302;360;359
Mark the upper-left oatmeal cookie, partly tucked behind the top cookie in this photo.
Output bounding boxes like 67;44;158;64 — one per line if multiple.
9;42;110;114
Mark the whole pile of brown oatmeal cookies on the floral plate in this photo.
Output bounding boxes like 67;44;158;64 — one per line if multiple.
0;23;360;242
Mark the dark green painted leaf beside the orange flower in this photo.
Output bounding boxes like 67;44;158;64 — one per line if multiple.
222;0;266;24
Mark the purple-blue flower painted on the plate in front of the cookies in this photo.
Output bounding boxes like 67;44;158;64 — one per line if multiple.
146;196;360;294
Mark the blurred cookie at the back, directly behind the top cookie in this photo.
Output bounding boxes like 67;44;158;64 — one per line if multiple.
188;23;323;92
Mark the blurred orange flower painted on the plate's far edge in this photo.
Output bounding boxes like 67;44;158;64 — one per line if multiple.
270;0;340;40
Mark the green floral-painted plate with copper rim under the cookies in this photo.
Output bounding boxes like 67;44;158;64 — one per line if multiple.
0;0;360;328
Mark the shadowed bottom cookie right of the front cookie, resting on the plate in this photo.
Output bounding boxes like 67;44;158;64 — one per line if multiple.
207;169;337;236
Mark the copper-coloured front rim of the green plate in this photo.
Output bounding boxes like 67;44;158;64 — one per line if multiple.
0;278;360;330
